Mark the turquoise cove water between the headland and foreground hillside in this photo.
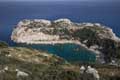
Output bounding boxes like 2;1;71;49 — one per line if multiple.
19;44;96;62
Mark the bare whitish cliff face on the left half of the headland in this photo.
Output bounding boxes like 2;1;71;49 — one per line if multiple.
17;32;59;43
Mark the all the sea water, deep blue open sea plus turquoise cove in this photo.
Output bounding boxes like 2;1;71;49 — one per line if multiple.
0;1;120;61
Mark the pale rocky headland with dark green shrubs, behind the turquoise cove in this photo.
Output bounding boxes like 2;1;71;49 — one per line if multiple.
11;19;120;65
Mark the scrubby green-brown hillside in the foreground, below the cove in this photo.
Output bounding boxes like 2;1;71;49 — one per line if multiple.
0;42;120;80
